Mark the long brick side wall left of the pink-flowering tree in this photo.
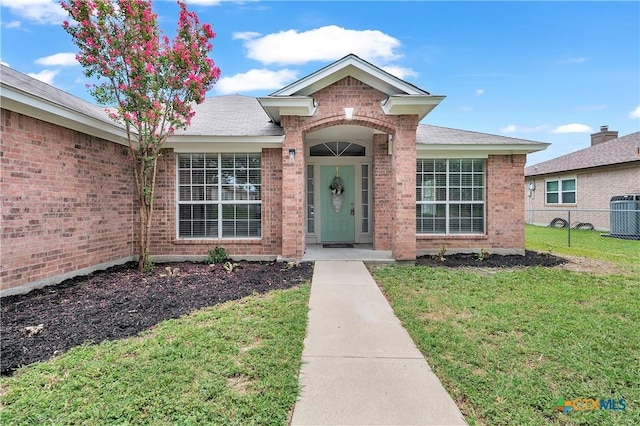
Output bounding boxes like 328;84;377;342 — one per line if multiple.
0;109;134;290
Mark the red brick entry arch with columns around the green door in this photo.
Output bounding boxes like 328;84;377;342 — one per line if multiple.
282;77;418;259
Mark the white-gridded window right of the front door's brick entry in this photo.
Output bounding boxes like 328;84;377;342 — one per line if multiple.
416;158;485;234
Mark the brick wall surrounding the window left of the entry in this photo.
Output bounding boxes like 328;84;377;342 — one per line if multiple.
149;148;282;259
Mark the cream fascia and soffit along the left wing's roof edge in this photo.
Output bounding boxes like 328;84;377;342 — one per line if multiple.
1;85;128;145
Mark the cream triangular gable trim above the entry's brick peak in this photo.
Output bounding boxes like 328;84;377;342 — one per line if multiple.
269;54;429;96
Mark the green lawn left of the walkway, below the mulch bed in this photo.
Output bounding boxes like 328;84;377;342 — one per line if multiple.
0;284;309;425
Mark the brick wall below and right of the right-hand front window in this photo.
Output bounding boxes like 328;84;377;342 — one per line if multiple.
418;154;526;253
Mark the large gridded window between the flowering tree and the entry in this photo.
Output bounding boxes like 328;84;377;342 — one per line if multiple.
178;154;262;238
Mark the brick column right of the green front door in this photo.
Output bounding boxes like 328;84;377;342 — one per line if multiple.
391;115;418;260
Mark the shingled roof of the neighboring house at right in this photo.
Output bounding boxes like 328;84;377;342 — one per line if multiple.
525;132;640;176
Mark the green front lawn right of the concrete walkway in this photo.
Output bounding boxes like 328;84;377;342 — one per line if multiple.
374;266;640;425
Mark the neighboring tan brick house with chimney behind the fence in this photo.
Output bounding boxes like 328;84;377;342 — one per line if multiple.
525;126;640;230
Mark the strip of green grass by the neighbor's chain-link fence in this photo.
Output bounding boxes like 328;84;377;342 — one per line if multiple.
525;225;640;272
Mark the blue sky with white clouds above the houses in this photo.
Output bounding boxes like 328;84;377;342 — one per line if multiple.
0;0;640;165
